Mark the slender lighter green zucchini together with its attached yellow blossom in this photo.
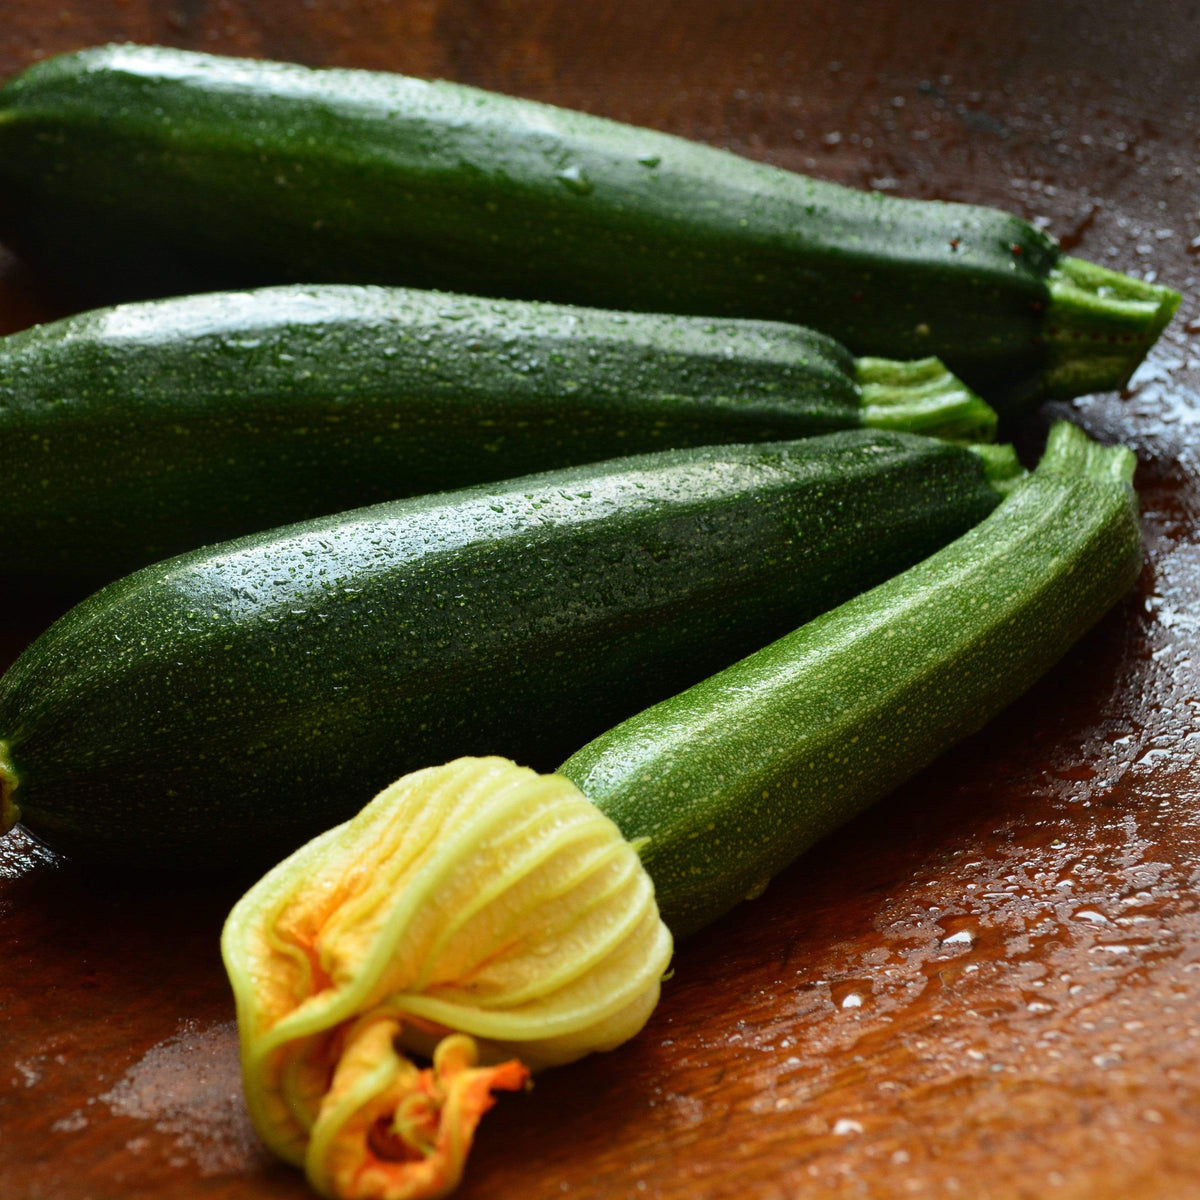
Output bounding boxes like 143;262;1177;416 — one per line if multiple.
223;424;1141;1200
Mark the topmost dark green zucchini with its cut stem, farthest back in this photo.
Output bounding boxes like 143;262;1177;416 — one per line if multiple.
0;46;1178;408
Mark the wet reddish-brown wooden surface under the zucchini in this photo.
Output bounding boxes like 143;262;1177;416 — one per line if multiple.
0;0;1200;1200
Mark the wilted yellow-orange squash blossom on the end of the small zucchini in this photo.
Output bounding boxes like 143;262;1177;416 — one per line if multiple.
221;758;671;1200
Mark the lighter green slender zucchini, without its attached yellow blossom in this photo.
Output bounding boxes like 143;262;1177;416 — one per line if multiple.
560;424;1141;936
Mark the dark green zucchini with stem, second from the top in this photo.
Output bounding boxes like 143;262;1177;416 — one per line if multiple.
0;284;995;582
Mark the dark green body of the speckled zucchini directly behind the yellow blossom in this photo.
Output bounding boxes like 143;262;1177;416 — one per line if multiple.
0;431;998;866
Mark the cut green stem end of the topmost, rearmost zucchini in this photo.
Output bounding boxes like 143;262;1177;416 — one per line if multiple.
1042;257;1181;400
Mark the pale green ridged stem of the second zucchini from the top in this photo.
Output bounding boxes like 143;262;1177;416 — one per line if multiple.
854;358;997;442
